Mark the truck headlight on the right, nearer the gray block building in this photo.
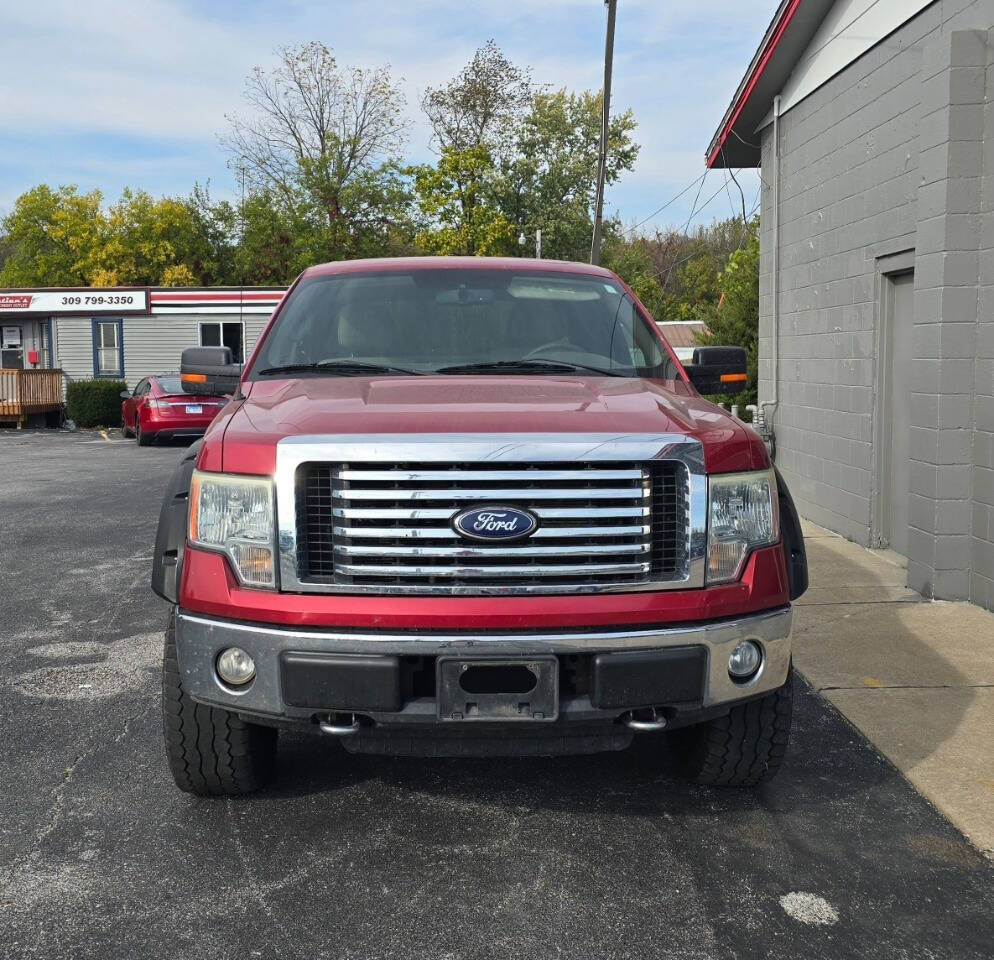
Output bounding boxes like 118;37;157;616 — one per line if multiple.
707;470;780;583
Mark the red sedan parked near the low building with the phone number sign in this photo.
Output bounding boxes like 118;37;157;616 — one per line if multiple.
121;373;229;447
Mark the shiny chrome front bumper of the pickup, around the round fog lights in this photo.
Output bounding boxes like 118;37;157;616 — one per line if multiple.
176;607;793;721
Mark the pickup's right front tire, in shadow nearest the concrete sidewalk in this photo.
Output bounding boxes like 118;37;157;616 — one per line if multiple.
687;670;794;787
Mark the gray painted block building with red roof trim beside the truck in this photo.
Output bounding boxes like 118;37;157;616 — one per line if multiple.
707;0;994;609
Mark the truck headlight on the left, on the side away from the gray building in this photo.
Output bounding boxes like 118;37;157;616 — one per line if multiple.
189;470;276;587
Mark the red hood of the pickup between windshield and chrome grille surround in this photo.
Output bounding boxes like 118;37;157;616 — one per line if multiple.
207;376;769;474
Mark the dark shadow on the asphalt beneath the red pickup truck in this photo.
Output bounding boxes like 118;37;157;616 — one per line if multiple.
264;678;924;816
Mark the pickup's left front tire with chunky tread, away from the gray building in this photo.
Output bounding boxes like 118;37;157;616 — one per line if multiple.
162;612;277;797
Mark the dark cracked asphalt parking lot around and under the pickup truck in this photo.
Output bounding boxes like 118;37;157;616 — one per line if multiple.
0;431;994;960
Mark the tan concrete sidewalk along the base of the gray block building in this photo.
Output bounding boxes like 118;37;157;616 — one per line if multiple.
794;522;994;856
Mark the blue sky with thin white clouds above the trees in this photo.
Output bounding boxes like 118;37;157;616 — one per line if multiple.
0;0;776;232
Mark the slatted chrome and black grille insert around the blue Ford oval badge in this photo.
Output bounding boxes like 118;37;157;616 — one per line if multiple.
295;461;689;593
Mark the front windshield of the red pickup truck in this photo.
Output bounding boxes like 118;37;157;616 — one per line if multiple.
251;269;679;380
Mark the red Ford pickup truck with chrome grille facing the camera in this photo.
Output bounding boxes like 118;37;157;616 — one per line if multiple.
153;258;807;795
